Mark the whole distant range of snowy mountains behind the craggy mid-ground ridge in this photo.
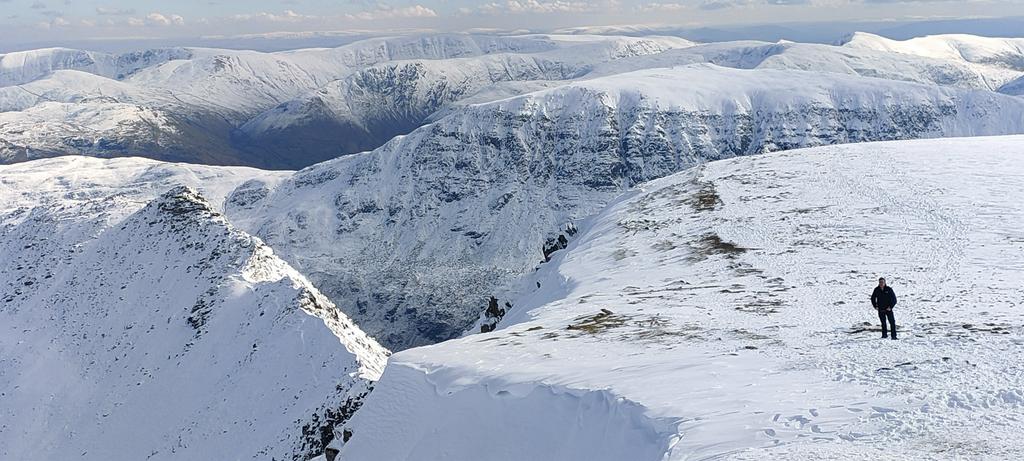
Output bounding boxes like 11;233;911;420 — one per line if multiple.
0;34;1024;169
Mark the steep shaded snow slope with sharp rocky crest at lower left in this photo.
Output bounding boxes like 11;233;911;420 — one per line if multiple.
0;157;386;460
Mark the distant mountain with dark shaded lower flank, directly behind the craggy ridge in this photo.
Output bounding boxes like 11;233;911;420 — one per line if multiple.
238;37;692;165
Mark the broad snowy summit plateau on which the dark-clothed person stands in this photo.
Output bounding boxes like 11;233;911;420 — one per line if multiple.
340;136;1024;461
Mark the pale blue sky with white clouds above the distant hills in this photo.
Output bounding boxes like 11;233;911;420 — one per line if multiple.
0;0;1024;49
